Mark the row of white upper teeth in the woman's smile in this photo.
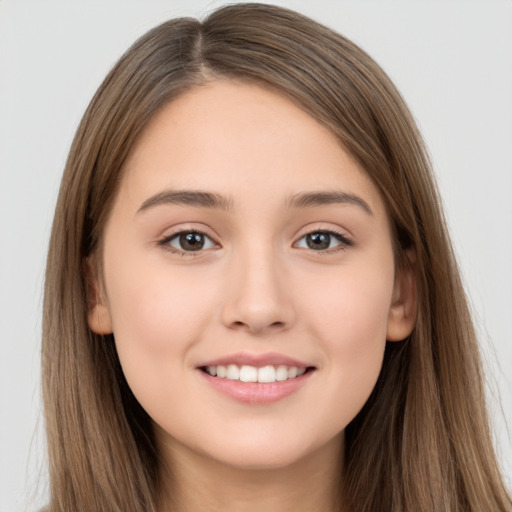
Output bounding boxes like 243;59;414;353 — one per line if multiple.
206;364;306;383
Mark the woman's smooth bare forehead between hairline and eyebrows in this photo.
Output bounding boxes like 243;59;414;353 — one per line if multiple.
121;80;383;216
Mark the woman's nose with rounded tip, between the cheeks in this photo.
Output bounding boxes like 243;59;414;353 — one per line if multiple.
222;245;295;335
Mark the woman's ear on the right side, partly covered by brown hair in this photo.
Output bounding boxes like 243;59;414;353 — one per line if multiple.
386;248;418;341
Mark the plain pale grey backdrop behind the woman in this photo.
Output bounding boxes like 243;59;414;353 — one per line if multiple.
0;0;512;512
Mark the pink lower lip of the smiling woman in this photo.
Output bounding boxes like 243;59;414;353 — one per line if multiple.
197;370;313;404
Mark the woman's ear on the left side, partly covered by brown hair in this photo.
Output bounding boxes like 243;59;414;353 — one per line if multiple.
83;256;112;334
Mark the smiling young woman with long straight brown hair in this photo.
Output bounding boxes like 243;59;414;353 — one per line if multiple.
43;4;511;512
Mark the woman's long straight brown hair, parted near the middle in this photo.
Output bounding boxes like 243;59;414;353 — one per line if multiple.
43;4;511;512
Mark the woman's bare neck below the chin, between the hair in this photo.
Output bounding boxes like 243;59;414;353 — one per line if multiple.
160;437;342;512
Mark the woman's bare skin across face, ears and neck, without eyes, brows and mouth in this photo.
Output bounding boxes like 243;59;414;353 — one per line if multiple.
89;81;415;512
